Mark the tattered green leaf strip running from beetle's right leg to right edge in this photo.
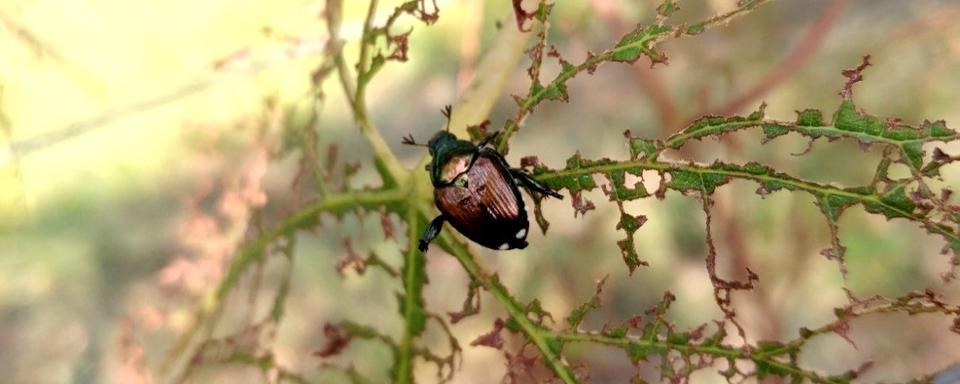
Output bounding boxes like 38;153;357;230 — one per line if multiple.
534;145;960;282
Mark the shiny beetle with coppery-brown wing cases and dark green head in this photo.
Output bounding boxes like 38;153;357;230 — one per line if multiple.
403;106;563;252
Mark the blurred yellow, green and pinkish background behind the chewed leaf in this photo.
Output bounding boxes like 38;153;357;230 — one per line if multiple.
0;0;960;383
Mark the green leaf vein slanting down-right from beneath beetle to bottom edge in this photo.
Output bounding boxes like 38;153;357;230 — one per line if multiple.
434;210;578;384
